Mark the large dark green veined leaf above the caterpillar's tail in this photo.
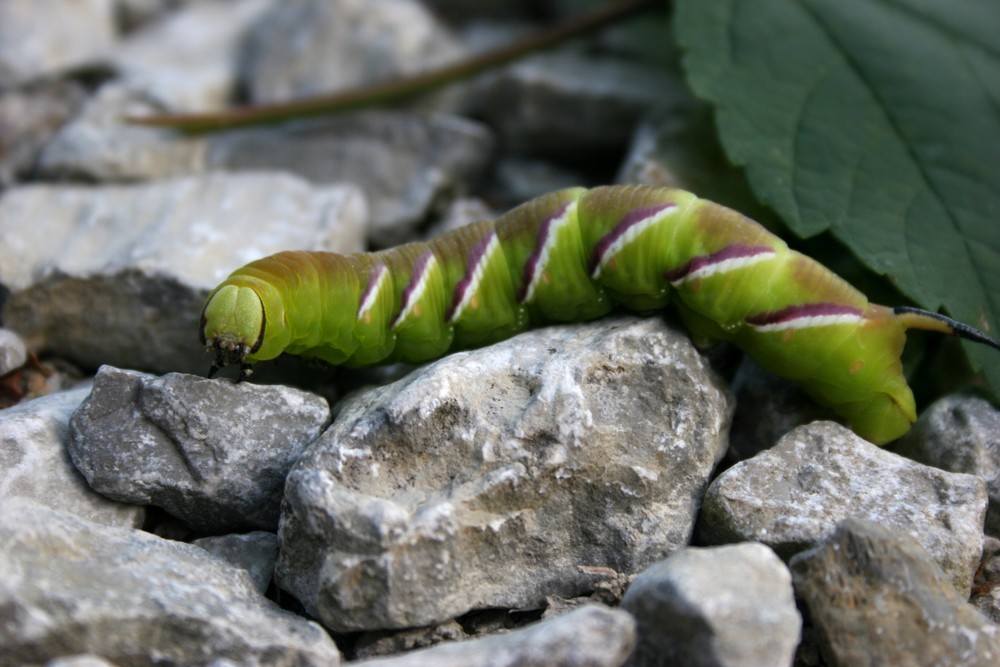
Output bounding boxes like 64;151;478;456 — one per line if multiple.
675;0;1000;390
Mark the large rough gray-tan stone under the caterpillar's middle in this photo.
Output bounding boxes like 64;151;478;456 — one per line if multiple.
276;318;731;631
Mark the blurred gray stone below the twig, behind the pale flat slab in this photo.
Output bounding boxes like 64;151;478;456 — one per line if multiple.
206;111;493;247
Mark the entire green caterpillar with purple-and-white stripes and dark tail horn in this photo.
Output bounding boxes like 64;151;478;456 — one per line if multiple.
200;185;1000;444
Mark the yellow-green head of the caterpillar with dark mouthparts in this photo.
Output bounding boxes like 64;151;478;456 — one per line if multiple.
199;284;267;382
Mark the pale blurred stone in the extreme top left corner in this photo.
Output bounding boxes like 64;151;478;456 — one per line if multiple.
0;0;115;90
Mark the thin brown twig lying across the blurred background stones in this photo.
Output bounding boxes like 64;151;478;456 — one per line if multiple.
125;0;663;132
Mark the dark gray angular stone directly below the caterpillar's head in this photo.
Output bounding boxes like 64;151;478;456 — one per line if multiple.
70;366;330;534
